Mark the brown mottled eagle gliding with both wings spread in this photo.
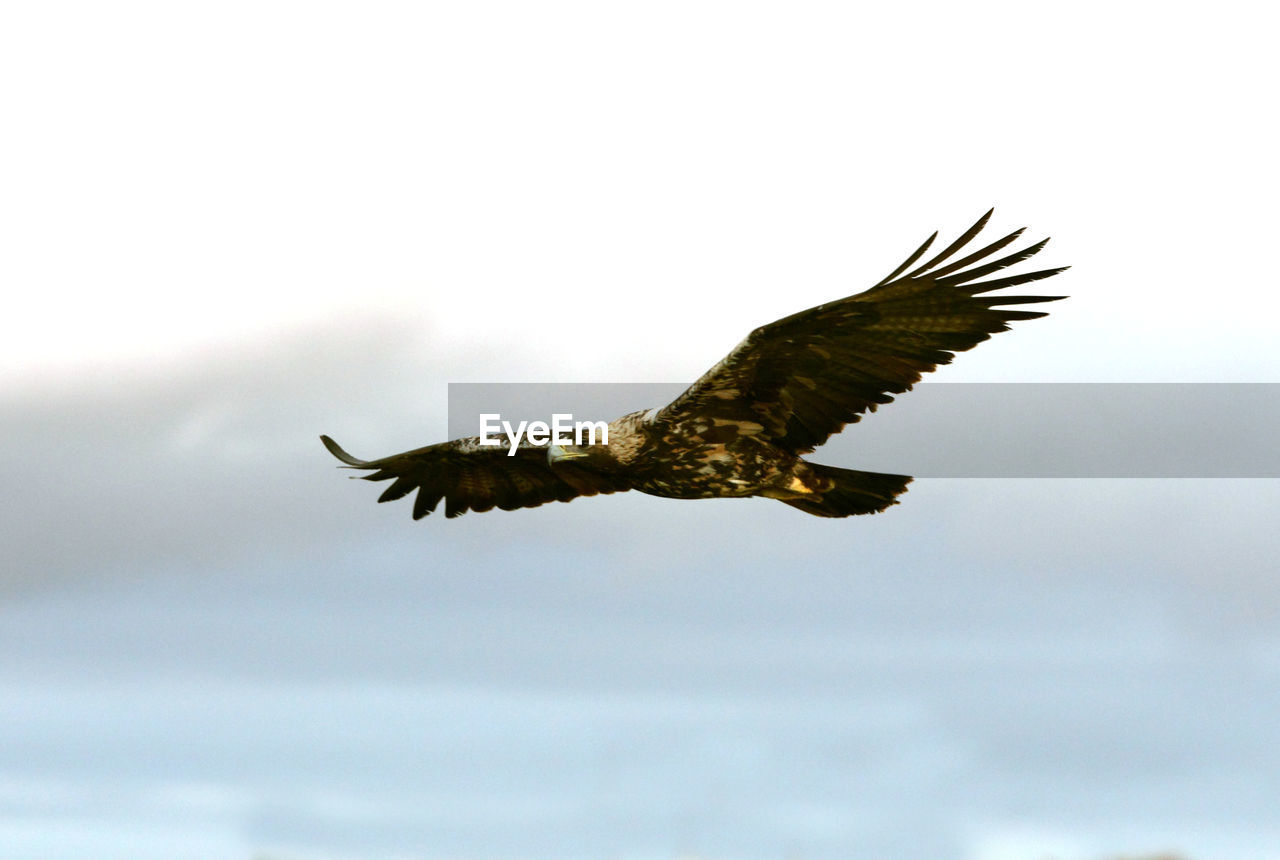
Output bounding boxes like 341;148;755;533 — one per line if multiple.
320;210;1068;520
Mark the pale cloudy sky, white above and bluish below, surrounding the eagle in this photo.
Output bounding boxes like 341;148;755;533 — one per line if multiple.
0;0;1280;860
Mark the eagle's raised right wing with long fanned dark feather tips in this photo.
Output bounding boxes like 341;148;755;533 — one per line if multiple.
654;210;1066;453
